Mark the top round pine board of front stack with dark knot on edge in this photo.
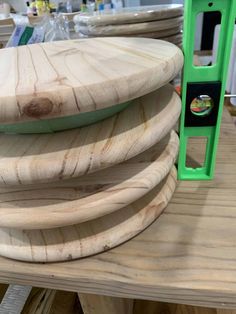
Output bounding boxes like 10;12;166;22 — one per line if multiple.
0;37;183;124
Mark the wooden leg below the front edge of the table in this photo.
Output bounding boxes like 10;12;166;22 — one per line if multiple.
79;294;133;314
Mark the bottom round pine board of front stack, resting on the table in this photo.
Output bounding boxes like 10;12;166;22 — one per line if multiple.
0;169;176;262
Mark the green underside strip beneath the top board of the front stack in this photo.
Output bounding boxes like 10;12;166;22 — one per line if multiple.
0;102;131;134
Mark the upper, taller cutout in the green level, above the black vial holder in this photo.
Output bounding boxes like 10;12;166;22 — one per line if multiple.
193;9;222;67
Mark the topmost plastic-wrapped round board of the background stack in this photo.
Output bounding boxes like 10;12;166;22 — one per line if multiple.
74;4;183;26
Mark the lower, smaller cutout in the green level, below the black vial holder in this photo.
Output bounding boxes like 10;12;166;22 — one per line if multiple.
186;136;208;169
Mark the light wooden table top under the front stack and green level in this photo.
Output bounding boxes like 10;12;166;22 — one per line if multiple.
0;109;236;308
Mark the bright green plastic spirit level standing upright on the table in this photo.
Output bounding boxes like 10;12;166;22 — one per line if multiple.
178;0;236;180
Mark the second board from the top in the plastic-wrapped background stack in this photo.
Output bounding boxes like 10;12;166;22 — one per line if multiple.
79;16;183;37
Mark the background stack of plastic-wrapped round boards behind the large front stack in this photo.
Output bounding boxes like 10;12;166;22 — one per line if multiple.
74;4;183;46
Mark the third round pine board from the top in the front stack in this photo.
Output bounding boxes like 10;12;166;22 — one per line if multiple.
0;131;179;229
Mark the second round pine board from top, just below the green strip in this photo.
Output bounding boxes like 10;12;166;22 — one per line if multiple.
0;85;181;186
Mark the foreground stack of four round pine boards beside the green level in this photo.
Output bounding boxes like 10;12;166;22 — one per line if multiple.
0;37;183;262
